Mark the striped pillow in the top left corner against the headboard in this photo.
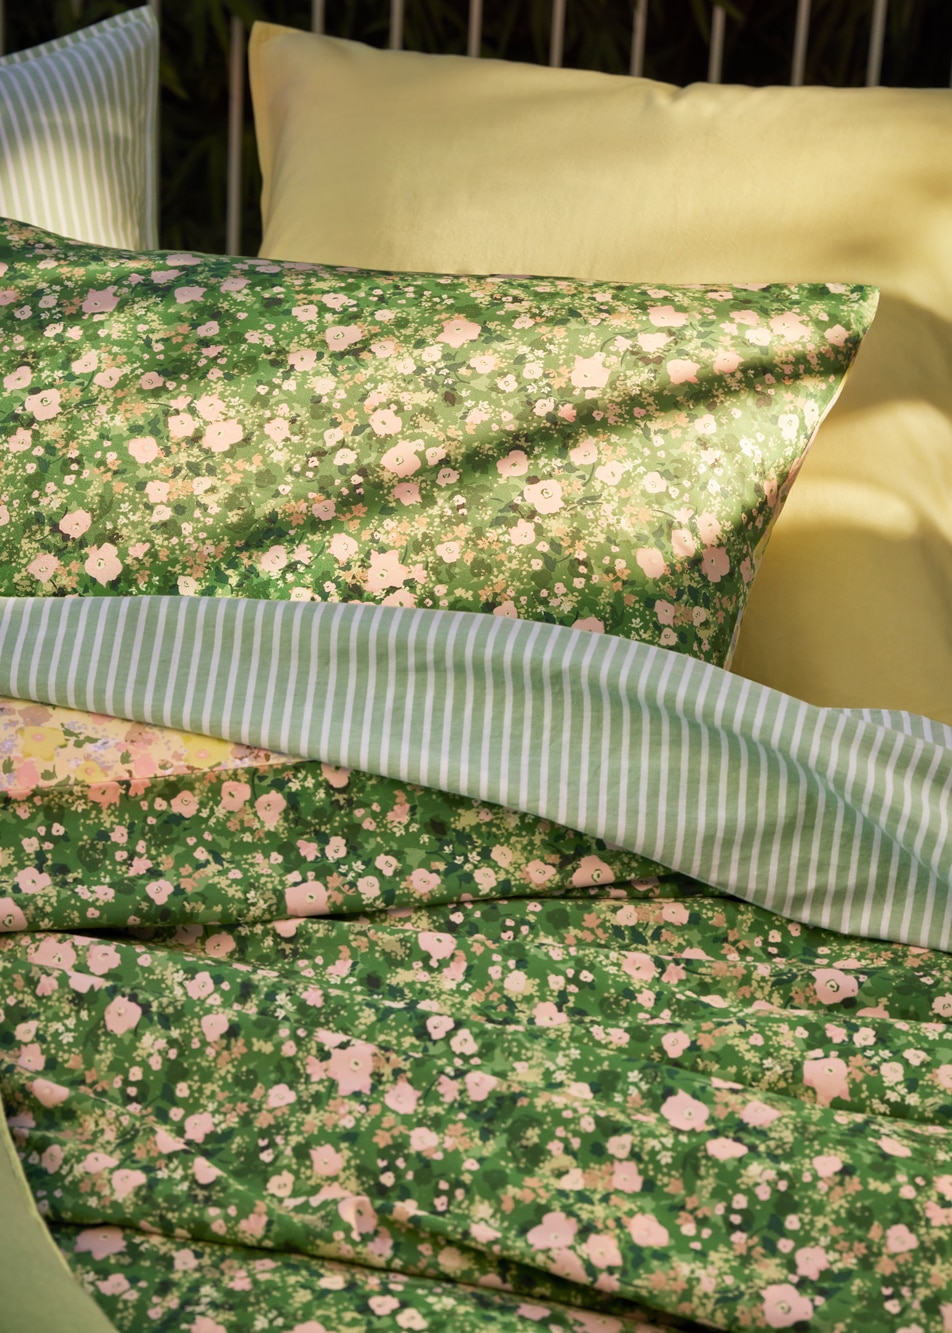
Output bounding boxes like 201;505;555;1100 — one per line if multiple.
0;5;159;249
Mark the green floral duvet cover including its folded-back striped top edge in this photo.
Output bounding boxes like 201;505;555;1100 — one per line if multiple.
0;599;952;1333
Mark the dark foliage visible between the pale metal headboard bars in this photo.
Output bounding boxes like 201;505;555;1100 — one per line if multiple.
7;0;952;253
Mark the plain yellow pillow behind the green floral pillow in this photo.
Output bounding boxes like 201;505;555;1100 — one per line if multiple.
251;24;952;722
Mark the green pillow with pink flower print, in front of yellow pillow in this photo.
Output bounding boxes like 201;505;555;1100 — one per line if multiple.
0;221;875;664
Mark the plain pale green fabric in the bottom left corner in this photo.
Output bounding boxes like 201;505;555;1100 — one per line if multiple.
0;1101;116;1333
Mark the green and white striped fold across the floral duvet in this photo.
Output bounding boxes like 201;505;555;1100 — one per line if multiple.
0;597;952;949
